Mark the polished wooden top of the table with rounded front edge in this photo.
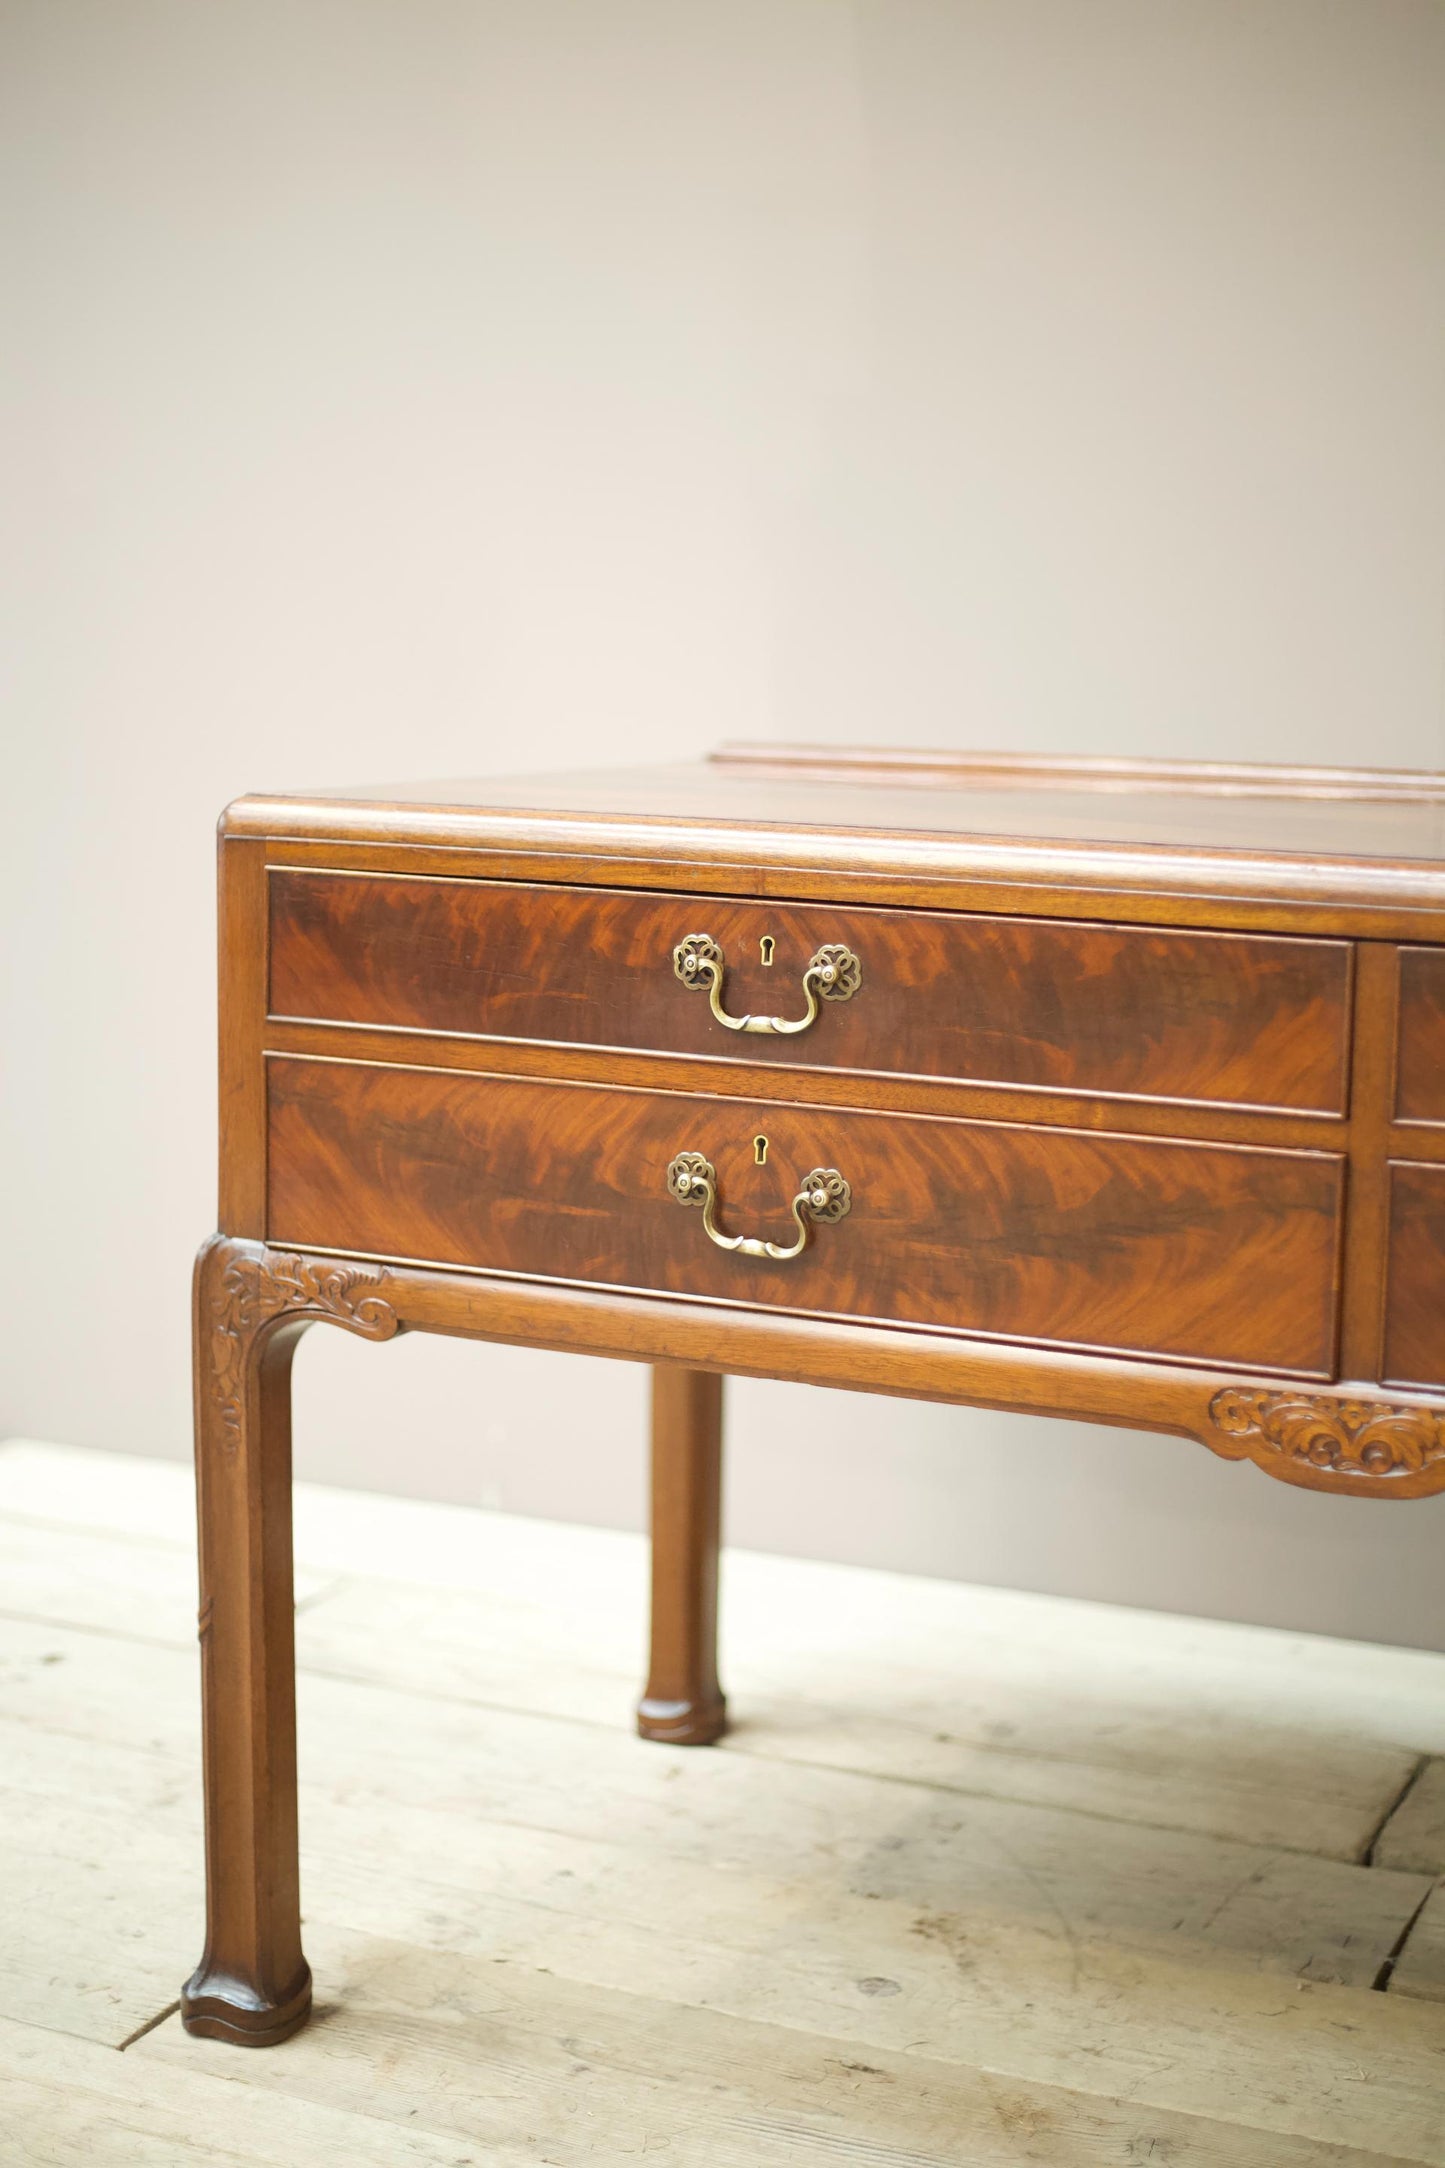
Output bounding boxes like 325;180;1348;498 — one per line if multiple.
223;746;1445;941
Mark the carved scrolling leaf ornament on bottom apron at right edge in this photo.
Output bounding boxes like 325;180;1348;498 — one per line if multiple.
1209;1385;1445;1485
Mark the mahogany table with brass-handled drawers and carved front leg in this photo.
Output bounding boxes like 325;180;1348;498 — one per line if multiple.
182;746;1445;2044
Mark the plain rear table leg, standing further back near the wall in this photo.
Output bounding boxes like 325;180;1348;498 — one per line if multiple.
637;1368;728;1747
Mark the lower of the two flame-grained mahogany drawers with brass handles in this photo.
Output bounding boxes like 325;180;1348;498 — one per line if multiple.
266;1056;1341;1377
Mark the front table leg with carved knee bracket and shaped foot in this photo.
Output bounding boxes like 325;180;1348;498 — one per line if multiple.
180;1236;396;2047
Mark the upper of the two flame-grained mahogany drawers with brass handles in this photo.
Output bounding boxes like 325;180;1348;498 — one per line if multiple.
271;869;1350;1114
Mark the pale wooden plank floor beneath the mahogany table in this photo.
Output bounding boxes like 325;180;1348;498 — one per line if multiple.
0;1444;1445;2168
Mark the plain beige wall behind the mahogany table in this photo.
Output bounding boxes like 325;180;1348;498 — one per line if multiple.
0;0;1445;1648
